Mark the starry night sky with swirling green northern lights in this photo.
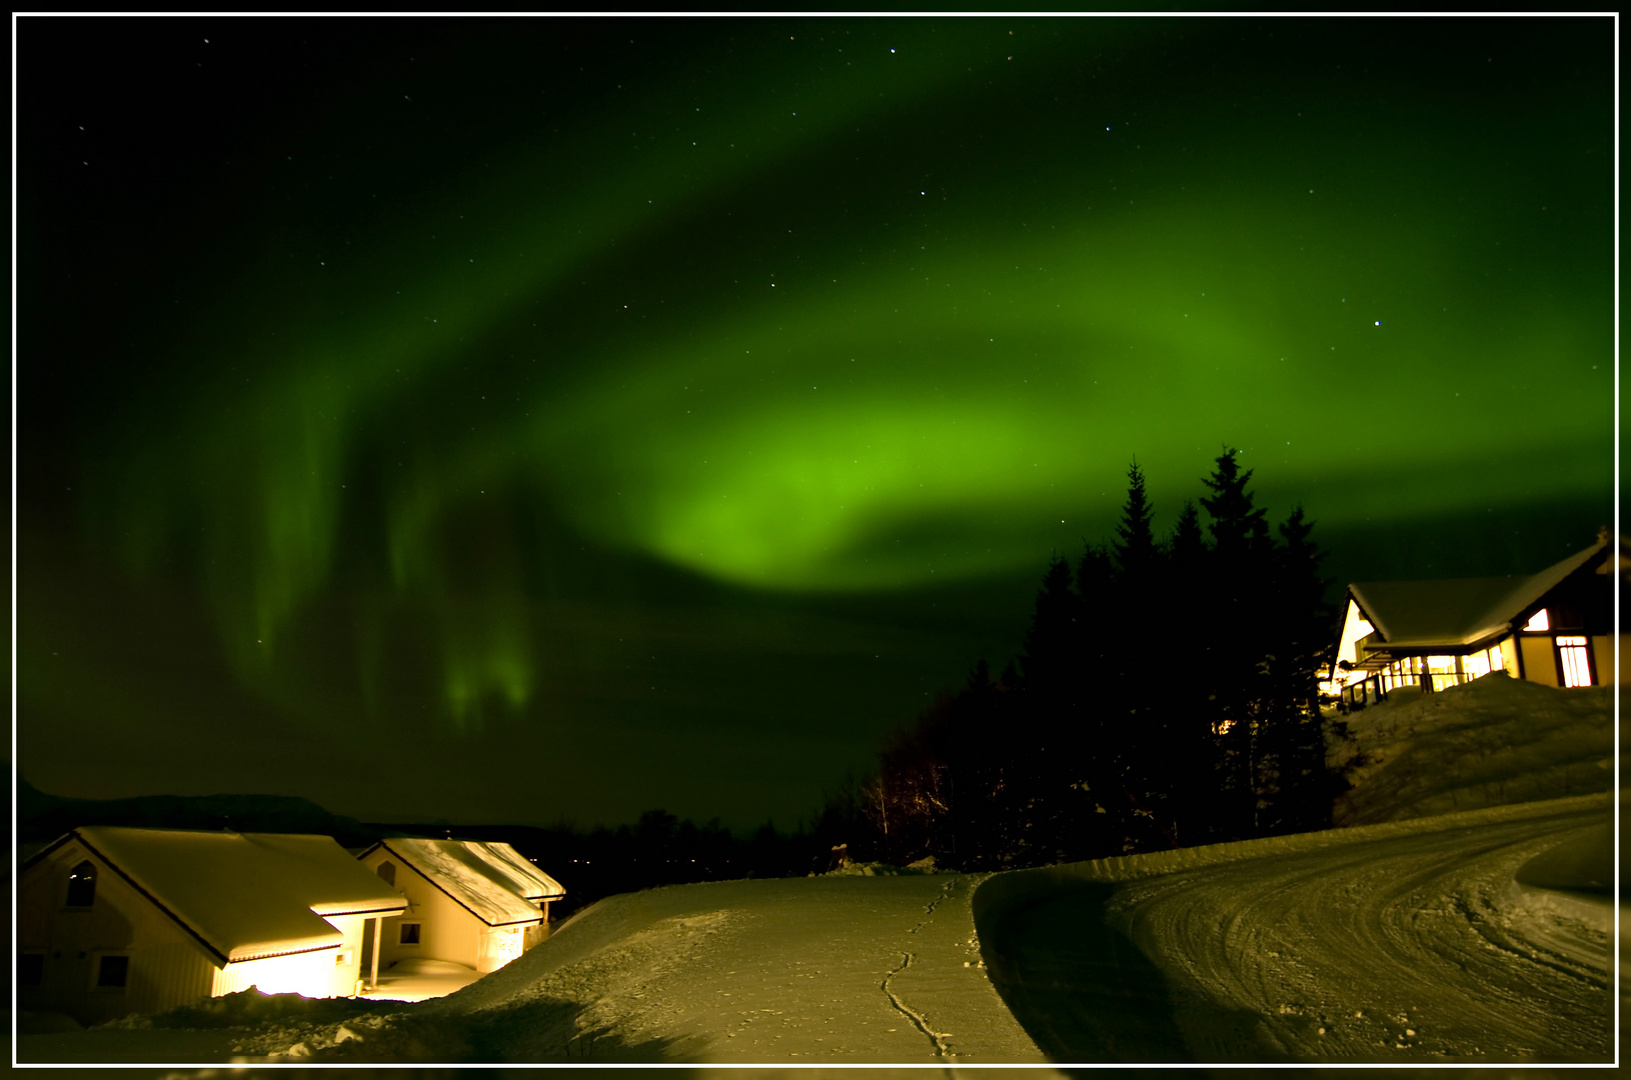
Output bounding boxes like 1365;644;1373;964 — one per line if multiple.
15;16;1615;829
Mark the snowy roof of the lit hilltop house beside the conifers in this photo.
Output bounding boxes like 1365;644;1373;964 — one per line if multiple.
1349;540;1608;648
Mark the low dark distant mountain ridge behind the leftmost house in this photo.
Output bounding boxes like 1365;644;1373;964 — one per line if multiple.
16;777;382;847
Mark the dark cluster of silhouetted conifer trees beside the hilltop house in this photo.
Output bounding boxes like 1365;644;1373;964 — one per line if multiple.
824;449;1344;870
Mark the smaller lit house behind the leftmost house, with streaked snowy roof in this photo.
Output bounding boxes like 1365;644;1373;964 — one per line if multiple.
357;837;566;972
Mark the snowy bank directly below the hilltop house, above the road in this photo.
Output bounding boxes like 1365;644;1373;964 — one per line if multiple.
1331;674;1615;825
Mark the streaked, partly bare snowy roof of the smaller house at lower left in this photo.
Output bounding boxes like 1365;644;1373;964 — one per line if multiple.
370;837;566;927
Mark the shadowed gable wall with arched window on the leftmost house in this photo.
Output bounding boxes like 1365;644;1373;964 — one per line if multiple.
18;840;215;1025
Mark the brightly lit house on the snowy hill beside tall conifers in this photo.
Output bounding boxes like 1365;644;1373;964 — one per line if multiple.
1329;530;1628;708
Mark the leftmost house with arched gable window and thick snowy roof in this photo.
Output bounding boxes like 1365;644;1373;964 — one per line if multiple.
18;825;406;1023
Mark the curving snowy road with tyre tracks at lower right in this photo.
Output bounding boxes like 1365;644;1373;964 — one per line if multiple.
980;796;1613;1064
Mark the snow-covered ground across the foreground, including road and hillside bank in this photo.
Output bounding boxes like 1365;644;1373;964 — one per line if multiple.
16;680;1618;1063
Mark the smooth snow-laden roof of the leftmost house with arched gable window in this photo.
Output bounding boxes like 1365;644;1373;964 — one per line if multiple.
52;825;406;963
